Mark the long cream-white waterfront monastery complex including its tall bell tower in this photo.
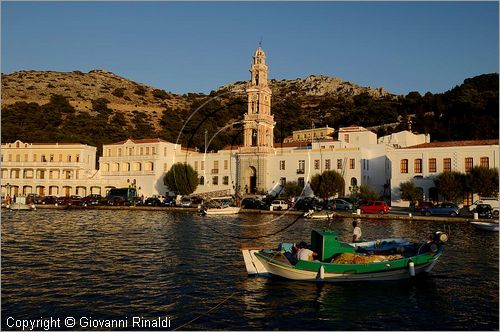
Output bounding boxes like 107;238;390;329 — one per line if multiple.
1;47;498;206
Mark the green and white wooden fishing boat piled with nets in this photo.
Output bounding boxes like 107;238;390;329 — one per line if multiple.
241;230;448;282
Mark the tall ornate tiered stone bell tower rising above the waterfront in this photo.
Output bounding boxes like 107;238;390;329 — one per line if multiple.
237;45;275;194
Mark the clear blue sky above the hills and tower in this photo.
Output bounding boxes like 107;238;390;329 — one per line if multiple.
1;1;499;94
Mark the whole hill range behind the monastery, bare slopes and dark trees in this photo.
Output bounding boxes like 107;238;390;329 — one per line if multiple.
1;69;498;149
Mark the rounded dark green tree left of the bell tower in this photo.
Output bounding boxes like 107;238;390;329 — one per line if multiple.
163;163;198;195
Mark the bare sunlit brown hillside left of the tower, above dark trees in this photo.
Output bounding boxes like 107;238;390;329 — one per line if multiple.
2;69;193;131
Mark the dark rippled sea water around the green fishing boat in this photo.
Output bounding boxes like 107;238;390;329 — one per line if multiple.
1;210;499;330
